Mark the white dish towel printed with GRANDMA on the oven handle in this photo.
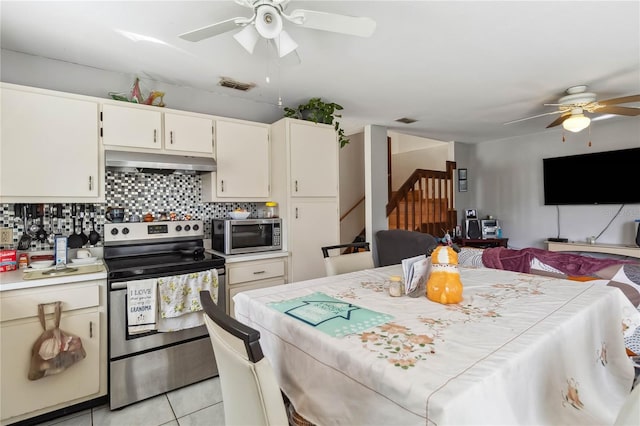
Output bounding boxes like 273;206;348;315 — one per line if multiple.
127;278;158;334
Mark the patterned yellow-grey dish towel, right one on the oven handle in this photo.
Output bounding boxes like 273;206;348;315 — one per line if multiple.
157;269;218;332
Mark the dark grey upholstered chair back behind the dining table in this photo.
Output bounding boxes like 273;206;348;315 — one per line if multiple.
376;229;438;266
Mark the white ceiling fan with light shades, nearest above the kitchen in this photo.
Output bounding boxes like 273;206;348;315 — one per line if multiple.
179;0;376;57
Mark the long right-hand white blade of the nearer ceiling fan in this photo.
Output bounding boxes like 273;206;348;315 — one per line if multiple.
285;9;376;37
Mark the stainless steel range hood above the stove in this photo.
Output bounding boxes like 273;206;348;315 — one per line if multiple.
104;150;216;174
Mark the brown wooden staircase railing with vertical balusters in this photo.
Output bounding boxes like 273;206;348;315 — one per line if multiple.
387;161;458;237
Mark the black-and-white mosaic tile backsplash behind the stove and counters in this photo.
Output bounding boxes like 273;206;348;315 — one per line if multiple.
0;170;258;251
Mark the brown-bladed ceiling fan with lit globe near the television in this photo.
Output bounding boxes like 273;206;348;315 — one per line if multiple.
504;86;640;132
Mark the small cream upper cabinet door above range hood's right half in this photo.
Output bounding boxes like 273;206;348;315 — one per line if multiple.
164;112;213;155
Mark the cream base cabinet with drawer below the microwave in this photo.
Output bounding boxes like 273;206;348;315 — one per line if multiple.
226;258;287;318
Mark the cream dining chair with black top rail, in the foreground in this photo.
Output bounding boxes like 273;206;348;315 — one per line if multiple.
200;291;289;426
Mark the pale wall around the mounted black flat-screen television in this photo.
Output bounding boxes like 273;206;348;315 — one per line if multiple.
456;117;640;248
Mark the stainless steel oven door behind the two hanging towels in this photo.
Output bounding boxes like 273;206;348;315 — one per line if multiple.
109;269;225;359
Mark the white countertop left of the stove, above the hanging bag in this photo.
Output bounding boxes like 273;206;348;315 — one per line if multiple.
0;259;107;291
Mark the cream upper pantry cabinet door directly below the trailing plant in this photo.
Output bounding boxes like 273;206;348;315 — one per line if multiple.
289;121;338;197
